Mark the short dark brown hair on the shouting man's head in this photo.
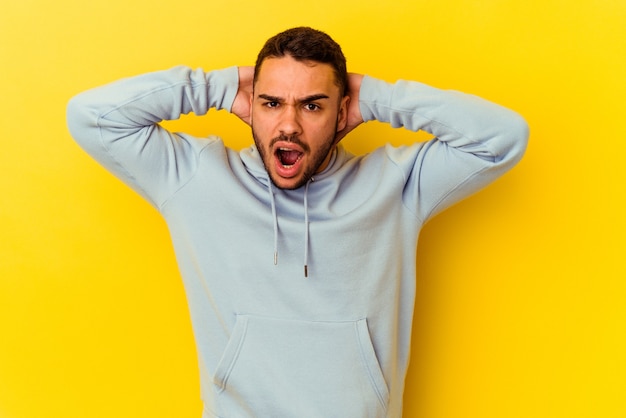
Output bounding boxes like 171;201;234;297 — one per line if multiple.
254;27;348;96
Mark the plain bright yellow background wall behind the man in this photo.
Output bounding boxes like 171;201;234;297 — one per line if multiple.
0;0;626;418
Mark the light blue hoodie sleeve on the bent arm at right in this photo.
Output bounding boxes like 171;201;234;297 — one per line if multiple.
359;77;529;222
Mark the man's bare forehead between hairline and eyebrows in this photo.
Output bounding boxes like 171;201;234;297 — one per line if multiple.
254;56;339;96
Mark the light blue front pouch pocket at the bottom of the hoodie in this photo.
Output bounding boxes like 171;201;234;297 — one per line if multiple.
213;315;389;418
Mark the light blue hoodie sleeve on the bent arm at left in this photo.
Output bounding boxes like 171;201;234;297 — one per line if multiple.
67;66;239;208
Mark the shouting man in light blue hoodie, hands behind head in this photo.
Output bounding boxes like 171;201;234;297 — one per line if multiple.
68;28;528;418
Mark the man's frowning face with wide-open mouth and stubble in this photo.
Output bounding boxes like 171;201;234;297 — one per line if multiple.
250;56;348;189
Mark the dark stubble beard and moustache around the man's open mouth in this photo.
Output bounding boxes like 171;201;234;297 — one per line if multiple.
252;124;337;190
